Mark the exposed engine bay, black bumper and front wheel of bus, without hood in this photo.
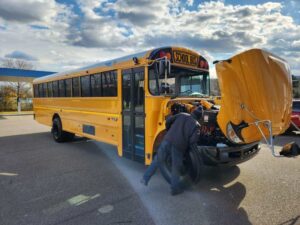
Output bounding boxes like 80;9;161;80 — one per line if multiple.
163;98;260;183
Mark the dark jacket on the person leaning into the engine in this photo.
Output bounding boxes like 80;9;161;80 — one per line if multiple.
164;113;200;152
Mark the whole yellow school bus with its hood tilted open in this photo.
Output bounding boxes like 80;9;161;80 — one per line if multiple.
33;47;292;176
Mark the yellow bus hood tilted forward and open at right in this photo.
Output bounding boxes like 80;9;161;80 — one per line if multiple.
216;49;292;143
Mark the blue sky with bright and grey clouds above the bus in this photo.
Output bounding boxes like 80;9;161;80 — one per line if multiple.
0;0;300;76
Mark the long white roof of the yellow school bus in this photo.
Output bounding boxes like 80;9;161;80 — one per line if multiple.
33;46;204;83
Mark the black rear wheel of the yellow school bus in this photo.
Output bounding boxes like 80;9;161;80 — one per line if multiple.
51;117;75;143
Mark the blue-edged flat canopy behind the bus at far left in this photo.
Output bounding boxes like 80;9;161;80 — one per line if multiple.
0;68;55;83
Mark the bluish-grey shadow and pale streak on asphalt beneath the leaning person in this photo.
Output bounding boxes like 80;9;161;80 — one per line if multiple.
99;141;251;225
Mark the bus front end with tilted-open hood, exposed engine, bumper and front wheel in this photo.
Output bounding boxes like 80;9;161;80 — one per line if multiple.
161;49;292;182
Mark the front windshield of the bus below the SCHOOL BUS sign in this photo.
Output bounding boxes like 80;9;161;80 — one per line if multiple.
149;65;209;97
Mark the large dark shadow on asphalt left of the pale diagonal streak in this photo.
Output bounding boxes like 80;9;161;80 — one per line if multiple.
0;132;153;225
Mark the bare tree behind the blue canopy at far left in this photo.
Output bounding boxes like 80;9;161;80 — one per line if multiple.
1;59;34;110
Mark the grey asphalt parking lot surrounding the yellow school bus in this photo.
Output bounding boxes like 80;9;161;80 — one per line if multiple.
0;116;300;225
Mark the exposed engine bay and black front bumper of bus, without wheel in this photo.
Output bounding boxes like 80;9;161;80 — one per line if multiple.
169;99;259;158
